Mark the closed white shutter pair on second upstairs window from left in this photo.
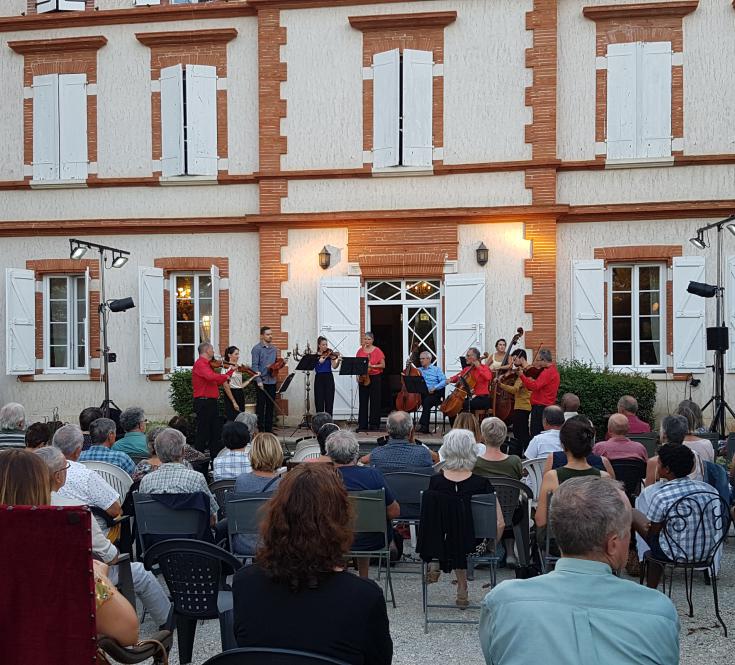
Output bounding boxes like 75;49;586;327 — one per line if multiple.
160;65;218;176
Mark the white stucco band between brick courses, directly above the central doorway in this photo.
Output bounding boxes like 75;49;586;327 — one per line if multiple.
282;171;531;212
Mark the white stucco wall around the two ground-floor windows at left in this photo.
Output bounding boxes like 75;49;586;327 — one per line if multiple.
0;233;259;422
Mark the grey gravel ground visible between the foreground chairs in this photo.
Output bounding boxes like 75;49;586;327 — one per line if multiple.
125;540;735;665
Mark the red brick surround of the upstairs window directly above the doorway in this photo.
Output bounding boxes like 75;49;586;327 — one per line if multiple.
349;11;457;170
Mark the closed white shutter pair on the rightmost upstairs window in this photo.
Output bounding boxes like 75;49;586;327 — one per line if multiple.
606;42;672;160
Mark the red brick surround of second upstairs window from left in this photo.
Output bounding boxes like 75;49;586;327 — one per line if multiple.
135;28;237;179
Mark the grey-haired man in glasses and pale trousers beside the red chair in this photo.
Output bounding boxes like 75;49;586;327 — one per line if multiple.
36;444;171;626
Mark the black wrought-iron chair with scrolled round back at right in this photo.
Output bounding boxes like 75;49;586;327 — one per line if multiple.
640;492;730;637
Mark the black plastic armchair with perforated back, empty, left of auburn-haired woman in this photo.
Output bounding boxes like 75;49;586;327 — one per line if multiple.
145;538;242;665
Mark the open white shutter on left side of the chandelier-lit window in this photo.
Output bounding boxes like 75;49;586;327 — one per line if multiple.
138;266;166;374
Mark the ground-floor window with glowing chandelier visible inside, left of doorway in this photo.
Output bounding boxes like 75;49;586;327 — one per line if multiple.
171;273;219;367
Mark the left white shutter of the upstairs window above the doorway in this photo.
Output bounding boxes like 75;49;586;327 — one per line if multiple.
373;49;401;168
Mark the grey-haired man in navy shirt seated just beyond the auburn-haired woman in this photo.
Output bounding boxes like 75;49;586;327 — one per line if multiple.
327;430;401;577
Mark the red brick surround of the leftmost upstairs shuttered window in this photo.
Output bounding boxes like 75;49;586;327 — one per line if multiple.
8;35;107;184
